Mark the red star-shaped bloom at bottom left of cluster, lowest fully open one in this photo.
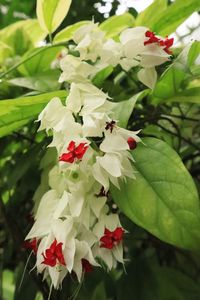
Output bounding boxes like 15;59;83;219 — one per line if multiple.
42;239;66;267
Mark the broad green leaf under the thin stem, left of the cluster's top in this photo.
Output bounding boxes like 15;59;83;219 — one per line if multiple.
18;46;63;76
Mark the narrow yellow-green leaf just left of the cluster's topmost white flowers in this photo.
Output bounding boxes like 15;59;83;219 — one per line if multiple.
53;21;91;43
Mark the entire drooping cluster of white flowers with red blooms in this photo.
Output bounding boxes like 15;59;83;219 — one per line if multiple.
26;23;173;288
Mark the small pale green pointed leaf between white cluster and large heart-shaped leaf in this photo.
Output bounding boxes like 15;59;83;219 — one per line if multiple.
113;90;149;128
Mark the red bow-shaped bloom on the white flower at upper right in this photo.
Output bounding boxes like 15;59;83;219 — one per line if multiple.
144;31;174;54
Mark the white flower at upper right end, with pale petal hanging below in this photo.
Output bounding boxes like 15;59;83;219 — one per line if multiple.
120;27;170;89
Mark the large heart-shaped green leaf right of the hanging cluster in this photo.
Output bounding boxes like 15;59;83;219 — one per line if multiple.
111;138;200;249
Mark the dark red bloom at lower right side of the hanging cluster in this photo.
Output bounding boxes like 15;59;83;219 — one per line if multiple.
100;227;124;249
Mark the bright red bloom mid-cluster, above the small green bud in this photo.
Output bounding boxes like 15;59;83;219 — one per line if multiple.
59;141;88;163
